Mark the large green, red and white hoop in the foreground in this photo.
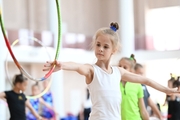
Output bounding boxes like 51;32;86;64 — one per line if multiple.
0;0;62;81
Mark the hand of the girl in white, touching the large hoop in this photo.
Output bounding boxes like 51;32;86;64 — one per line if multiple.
43;61;61;72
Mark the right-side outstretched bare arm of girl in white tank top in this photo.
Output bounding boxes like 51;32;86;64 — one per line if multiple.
119;68;180;95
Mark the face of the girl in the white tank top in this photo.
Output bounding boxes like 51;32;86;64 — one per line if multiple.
95;34;115;60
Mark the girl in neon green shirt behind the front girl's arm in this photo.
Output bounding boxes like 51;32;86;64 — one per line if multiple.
119;54;149;120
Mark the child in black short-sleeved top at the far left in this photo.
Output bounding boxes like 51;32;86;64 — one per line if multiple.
0;74;42;120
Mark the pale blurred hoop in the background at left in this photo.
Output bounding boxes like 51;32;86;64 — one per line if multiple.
5;38;52;99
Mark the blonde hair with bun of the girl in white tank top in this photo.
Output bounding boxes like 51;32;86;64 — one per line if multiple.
92;22;120;51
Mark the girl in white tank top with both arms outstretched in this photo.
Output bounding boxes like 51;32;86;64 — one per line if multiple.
43;23;180;120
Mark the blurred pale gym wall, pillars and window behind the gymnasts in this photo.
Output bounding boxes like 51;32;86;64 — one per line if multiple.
0;0;180;120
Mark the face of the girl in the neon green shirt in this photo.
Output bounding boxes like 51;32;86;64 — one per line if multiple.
119;59;132;72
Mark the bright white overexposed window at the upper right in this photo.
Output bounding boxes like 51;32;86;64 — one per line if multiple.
146;7;180;51
